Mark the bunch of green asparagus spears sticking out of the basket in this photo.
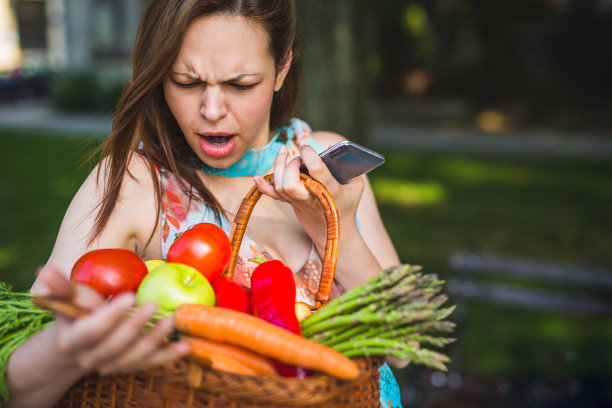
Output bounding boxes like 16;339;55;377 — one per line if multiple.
302;265;455;371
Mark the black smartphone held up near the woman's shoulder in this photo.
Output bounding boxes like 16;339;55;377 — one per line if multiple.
300;140;385;184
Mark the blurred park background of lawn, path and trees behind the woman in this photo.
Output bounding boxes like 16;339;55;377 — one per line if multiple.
0;0;612;407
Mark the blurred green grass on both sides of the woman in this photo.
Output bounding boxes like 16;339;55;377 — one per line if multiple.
0;130;612;386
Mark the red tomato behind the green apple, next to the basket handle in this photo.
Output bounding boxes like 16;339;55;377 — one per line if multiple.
166;222;232;282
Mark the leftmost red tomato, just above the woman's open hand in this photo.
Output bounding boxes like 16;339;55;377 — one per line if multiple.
70;248;147;298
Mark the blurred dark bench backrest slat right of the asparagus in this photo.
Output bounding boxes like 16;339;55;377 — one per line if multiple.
446;252;612;315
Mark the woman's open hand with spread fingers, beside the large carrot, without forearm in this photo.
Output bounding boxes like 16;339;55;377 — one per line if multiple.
41;268;188;374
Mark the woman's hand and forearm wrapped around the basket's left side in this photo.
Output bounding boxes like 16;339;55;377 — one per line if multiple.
6;267;187;408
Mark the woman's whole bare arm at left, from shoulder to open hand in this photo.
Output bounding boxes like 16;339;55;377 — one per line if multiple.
6;155;187;407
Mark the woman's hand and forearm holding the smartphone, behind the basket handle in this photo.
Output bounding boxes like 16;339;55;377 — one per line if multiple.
254;146;399;290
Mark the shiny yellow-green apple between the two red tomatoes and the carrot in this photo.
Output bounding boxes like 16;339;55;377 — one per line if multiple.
136;263;215;312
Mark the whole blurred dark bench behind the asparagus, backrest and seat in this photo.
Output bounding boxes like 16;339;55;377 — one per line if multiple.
402;251;612;408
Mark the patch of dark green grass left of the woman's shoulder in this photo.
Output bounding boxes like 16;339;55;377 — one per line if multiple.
0;129;98;290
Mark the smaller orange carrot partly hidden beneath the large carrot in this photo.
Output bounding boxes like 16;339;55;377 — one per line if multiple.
181;336;278;375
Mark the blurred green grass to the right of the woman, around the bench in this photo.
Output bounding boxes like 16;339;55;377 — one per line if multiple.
370;152;612;381
